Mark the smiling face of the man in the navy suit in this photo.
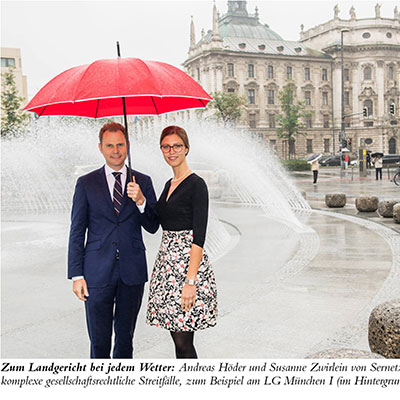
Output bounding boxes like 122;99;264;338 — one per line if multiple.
99;131;127;171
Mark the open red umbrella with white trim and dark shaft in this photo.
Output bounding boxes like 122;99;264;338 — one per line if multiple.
24;44;212;180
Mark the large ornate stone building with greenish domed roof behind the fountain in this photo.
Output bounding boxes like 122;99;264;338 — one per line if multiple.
184;1;400;157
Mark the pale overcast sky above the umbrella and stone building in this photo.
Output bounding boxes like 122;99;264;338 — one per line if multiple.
1;0;400;98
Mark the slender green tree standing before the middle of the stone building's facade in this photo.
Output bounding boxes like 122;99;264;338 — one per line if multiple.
277;85;311;158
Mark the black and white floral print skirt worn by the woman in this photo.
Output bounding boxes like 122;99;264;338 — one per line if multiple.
146;230;217;332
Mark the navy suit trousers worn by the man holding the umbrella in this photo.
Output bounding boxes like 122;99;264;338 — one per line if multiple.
85;260;144;358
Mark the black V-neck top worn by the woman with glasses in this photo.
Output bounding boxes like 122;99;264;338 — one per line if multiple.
156;173;208;247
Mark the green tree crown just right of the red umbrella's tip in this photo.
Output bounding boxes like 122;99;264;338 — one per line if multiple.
208;92;245;125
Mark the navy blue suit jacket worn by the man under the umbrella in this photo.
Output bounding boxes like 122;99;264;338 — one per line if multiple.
68;167;159;287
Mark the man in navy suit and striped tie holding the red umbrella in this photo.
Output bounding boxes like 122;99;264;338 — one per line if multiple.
68;122;159;358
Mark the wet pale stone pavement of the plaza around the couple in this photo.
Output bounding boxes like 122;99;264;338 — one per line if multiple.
1;164;400;358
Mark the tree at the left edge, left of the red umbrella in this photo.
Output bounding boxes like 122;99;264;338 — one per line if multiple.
1;68;29;138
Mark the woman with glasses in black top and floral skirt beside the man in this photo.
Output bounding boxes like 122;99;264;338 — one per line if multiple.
146;126;217;358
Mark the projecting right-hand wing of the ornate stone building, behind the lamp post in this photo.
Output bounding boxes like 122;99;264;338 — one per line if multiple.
300;4;400;154
